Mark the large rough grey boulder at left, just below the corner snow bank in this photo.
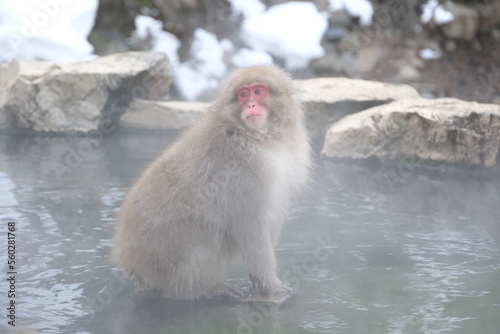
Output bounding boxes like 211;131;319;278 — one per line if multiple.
0;51;171;132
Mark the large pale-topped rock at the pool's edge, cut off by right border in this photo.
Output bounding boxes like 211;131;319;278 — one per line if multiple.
322;98;500;168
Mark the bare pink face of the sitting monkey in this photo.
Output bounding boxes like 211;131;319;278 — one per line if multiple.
236;82;269;127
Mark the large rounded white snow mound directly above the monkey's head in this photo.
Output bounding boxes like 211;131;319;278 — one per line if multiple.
240;0;328;69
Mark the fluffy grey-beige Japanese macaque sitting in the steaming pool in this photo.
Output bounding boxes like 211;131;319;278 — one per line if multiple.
113;65;311;300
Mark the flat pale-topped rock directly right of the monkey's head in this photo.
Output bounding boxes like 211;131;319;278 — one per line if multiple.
297;78;419;146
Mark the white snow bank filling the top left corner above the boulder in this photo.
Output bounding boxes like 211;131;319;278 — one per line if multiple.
0;0;98;63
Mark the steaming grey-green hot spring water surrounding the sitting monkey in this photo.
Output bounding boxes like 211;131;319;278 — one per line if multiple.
0;130;500;333
